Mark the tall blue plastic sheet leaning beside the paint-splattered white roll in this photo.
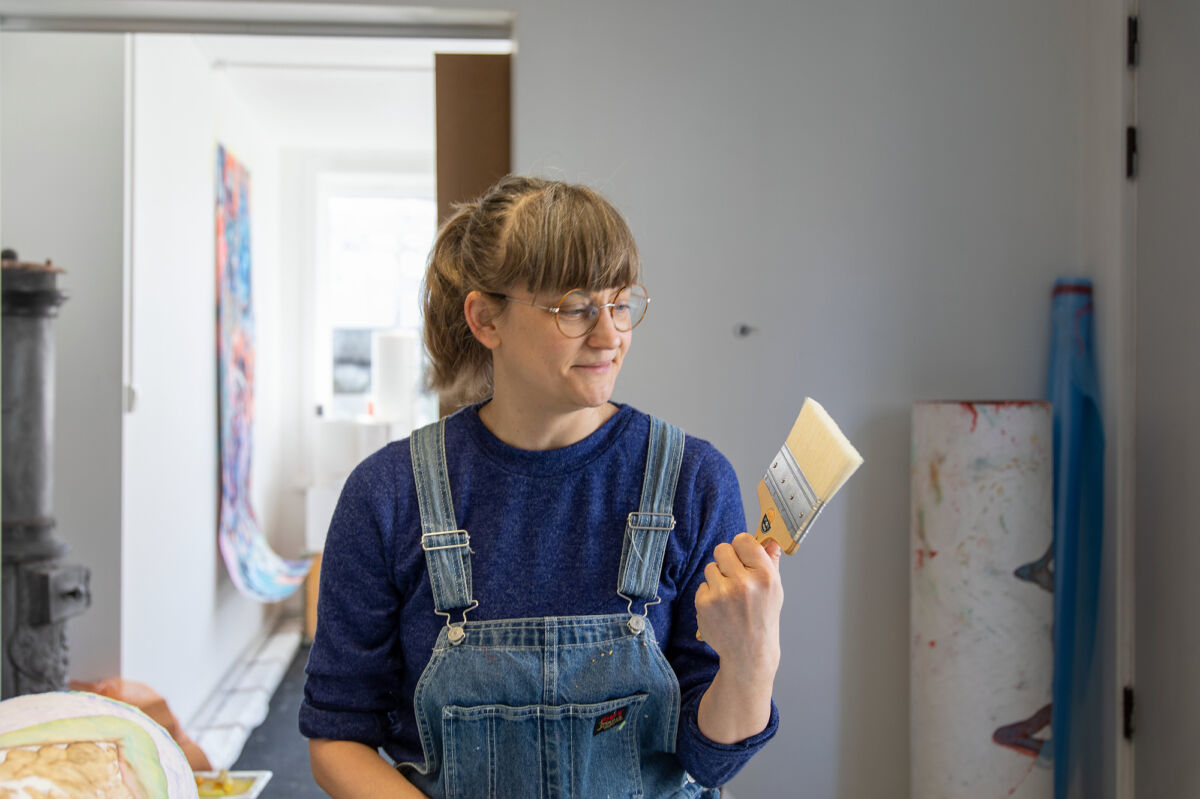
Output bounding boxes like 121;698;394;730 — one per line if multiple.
1048;278;1104;799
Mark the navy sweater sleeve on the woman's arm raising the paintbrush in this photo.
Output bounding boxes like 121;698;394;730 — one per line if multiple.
667;444;779;787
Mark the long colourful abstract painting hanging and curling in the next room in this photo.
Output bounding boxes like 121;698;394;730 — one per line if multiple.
216;145;310;602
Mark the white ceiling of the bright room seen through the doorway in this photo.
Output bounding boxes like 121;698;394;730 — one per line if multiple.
187;34;512;152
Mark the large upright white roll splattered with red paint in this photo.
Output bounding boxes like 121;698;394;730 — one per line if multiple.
910;402;1054;799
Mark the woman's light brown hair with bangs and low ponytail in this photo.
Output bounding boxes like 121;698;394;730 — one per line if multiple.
424;175;641;405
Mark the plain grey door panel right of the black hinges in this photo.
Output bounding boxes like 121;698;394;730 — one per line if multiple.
1135;0;1200;799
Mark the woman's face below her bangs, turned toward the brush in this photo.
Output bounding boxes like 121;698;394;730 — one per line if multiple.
492;288;632;413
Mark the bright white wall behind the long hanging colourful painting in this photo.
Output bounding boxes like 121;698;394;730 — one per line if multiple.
121;35;285;720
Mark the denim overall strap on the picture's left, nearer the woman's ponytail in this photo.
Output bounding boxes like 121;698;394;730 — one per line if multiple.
409;419;478;624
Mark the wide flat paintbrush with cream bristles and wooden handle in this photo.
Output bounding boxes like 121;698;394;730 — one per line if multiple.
755;397;863;554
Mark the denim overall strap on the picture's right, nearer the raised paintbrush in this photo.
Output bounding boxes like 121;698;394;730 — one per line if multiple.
617;416;684;612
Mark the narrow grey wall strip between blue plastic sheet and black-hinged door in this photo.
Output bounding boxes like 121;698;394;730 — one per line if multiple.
1078;0;1136;797
